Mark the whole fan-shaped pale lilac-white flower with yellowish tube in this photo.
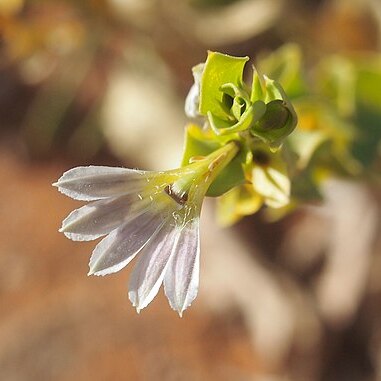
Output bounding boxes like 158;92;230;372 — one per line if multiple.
53;143;237;316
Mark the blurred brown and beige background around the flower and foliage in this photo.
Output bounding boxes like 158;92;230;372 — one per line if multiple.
0;0;381;381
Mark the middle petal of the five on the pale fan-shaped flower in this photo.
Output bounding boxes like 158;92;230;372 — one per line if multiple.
89;210;165;275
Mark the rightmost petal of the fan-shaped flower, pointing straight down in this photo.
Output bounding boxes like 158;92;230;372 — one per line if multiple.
164;217;200;316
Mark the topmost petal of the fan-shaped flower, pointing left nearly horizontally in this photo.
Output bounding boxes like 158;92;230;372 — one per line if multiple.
53;166;152;201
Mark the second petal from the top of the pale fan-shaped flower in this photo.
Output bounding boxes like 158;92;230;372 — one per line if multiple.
60;195;141;241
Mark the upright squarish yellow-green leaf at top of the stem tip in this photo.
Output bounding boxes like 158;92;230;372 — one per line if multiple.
200;52;249;118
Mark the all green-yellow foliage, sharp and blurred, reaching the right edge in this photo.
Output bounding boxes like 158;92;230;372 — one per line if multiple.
183;48;381;225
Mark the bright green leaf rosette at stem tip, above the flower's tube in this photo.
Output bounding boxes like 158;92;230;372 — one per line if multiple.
199;52;297;144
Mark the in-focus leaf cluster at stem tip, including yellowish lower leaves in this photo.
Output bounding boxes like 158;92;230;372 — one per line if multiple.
182;52;297;224
